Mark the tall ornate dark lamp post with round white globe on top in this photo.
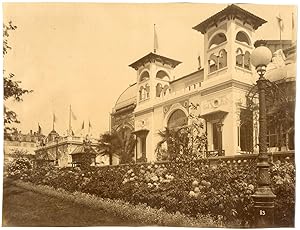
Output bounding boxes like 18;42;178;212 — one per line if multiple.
251;41;276;227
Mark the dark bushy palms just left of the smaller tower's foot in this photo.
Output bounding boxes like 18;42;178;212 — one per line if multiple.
98;128;136;165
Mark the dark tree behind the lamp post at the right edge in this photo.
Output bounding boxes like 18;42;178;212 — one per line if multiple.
246;79;296;151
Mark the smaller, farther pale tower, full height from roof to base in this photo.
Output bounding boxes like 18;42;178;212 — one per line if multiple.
129;52;181;162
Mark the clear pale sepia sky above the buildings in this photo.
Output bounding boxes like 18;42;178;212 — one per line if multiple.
3;3;297;137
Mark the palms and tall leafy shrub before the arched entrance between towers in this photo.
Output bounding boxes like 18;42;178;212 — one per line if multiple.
156;103;207;160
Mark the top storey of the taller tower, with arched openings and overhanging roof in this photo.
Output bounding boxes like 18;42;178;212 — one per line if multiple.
193;4;266;83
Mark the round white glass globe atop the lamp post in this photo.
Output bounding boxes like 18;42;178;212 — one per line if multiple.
250;46;272;68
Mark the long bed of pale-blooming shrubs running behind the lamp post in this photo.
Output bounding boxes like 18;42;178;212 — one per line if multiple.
9;158;295;227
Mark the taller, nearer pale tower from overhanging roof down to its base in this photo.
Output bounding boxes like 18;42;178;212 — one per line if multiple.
193;4;266;156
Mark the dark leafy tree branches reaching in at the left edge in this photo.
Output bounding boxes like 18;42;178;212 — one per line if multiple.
3;21;32;133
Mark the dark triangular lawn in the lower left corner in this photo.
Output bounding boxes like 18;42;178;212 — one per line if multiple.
2;182;138;227
